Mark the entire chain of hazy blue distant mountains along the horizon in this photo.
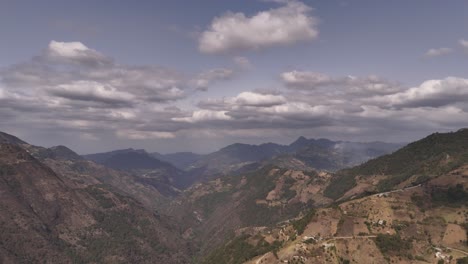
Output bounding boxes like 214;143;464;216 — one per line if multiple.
83;137;400;189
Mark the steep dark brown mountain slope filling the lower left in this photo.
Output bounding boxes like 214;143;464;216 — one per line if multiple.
0;133;189;263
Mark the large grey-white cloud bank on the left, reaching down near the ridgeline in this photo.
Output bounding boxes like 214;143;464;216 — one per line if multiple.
0;41;238;147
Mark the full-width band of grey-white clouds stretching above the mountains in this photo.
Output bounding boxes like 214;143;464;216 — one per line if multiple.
0;39;468;153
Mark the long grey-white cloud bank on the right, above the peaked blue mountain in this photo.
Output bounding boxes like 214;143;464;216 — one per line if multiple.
171;71;468;144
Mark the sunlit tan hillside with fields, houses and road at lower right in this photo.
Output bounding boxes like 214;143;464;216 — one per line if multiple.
236;166;468;264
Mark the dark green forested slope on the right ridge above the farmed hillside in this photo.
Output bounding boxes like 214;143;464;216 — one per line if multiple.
324;130;468;199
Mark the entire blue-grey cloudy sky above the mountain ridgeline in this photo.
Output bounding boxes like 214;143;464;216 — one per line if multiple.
0;0;468;154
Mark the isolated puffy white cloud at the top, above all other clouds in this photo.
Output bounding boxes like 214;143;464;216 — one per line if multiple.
198;1;319;54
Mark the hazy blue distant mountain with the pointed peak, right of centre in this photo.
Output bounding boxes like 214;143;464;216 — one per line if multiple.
187;137;401;178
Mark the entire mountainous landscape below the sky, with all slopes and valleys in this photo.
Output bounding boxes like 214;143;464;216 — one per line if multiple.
0;129;468;263
